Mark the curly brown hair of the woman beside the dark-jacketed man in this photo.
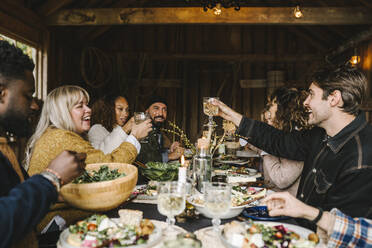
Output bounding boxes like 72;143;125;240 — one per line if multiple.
269;87;311;131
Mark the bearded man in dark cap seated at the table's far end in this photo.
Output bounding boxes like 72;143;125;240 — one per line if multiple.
137;96;183;167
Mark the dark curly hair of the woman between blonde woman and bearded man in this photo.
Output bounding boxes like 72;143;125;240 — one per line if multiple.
91;95;125;132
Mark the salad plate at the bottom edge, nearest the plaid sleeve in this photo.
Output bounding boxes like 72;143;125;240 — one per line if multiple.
219;221;319;248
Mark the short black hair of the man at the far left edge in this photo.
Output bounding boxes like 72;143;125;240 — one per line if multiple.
0;40;35;85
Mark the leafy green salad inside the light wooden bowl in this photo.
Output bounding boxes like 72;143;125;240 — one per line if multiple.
73;165;125;184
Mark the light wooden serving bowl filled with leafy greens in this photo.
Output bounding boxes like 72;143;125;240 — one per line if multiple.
61;163;138;211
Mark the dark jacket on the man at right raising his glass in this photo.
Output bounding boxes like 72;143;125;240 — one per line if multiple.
238;114;372;227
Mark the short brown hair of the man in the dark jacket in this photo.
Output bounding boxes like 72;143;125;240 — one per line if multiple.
309;65;367;115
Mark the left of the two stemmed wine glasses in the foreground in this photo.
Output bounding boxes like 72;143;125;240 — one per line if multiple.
158;181;186;231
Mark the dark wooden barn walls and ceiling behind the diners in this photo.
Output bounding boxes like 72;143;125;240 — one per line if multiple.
0;0;372;145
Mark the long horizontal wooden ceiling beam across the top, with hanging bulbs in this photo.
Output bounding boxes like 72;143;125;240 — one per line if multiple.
47;7;372;26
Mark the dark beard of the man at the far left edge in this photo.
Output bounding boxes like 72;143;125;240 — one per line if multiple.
0;109;32;137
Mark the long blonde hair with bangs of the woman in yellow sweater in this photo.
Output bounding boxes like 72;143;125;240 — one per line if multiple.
24;85;89;170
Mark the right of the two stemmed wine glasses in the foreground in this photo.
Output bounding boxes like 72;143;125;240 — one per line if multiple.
204;182;231;233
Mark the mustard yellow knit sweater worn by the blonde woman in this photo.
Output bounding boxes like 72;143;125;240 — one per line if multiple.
28;128;137;232
